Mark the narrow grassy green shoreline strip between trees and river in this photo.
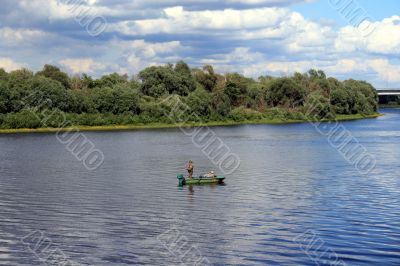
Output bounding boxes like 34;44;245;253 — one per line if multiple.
0;113;383;135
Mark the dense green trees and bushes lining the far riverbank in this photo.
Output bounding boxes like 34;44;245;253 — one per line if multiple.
0;61;377;128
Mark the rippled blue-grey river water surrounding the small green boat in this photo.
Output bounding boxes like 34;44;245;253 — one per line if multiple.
0;110;400;265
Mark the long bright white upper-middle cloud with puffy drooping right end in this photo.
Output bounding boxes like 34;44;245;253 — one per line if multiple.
109;6;336;53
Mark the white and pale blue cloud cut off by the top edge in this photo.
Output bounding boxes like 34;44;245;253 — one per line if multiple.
14;0;312;24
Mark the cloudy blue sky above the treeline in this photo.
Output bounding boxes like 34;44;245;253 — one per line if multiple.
0;0;400;88
